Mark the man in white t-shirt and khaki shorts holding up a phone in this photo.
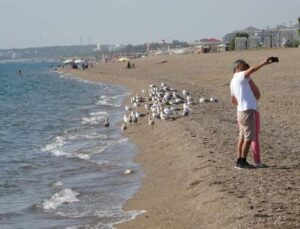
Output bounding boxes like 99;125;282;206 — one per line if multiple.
230;57;273;168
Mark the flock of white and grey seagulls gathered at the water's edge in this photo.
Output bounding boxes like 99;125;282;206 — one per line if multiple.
104;82;218;131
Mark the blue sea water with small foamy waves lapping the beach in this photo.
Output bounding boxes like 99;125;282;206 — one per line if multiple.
0;62;142;229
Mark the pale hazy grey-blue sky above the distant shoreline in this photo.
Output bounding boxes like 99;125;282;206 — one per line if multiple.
0;0;300;49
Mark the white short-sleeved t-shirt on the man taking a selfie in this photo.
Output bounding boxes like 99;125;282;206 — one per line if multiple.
230;71;258;111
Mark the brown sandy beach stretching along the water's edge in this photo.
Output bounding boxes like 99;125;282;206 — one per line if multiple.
65;49;300;229
